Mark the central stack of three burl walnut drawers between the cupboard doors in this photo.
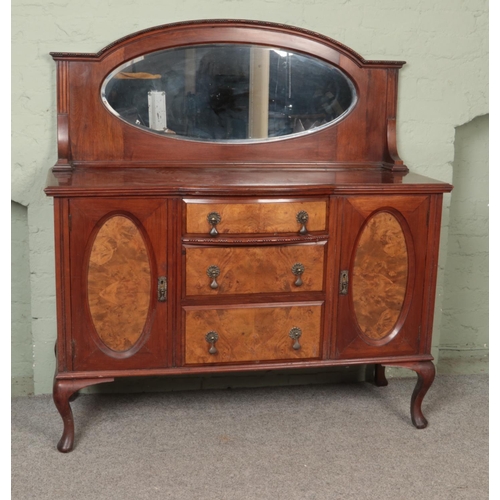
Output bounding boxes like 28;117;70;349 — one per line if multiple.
182;199;328;365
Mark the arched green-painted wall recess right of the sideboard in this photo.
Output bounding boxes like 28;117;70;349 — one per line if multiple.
440;115;489;368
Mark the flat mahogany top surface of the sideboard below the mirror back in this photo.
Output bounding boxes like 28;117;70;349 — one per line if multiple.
45;165;452;196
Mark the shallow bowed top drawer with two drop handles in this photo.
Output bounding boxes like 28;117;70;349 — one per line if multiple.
184;200;327;236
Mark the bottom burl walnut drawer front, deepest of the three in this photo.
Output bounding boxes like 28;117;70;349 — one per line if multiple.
184;302;323;364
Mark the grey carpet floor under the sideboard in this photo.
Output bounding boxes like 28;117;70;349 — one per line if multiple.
11;375;488;500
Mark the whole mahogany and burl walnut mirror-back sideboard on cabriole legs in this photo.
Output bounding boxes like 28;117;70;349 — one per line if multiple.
45;20;452;452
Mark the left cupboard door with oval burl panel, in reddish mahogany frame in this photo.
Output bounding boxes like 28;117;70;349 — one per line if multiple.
70;198;169;371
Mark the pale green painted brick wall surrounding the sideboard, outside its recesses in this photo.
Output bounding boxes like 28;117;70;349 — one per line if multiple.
12;0;488;394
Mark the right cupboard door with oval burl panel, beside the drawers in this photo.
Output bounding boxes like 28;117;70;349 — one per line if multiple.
334;195;429;359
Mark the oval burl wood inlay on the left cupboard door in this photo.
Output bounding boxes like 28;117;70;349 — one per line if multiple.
87;215;151;352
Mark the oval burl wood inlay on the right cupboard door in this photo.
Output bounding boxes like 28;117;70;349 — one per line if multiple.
352;212;408;340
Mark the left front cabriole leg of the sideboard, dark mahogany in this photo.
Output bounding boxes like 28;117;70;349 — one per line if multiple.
53;377;114;453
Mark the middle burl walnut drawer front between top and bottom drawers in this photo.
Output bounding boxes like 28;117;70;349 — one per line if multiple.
185;242;326;296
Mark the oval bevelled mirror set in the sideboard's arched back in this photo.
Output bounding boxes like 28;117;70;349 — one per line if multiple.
101;44;356;142
